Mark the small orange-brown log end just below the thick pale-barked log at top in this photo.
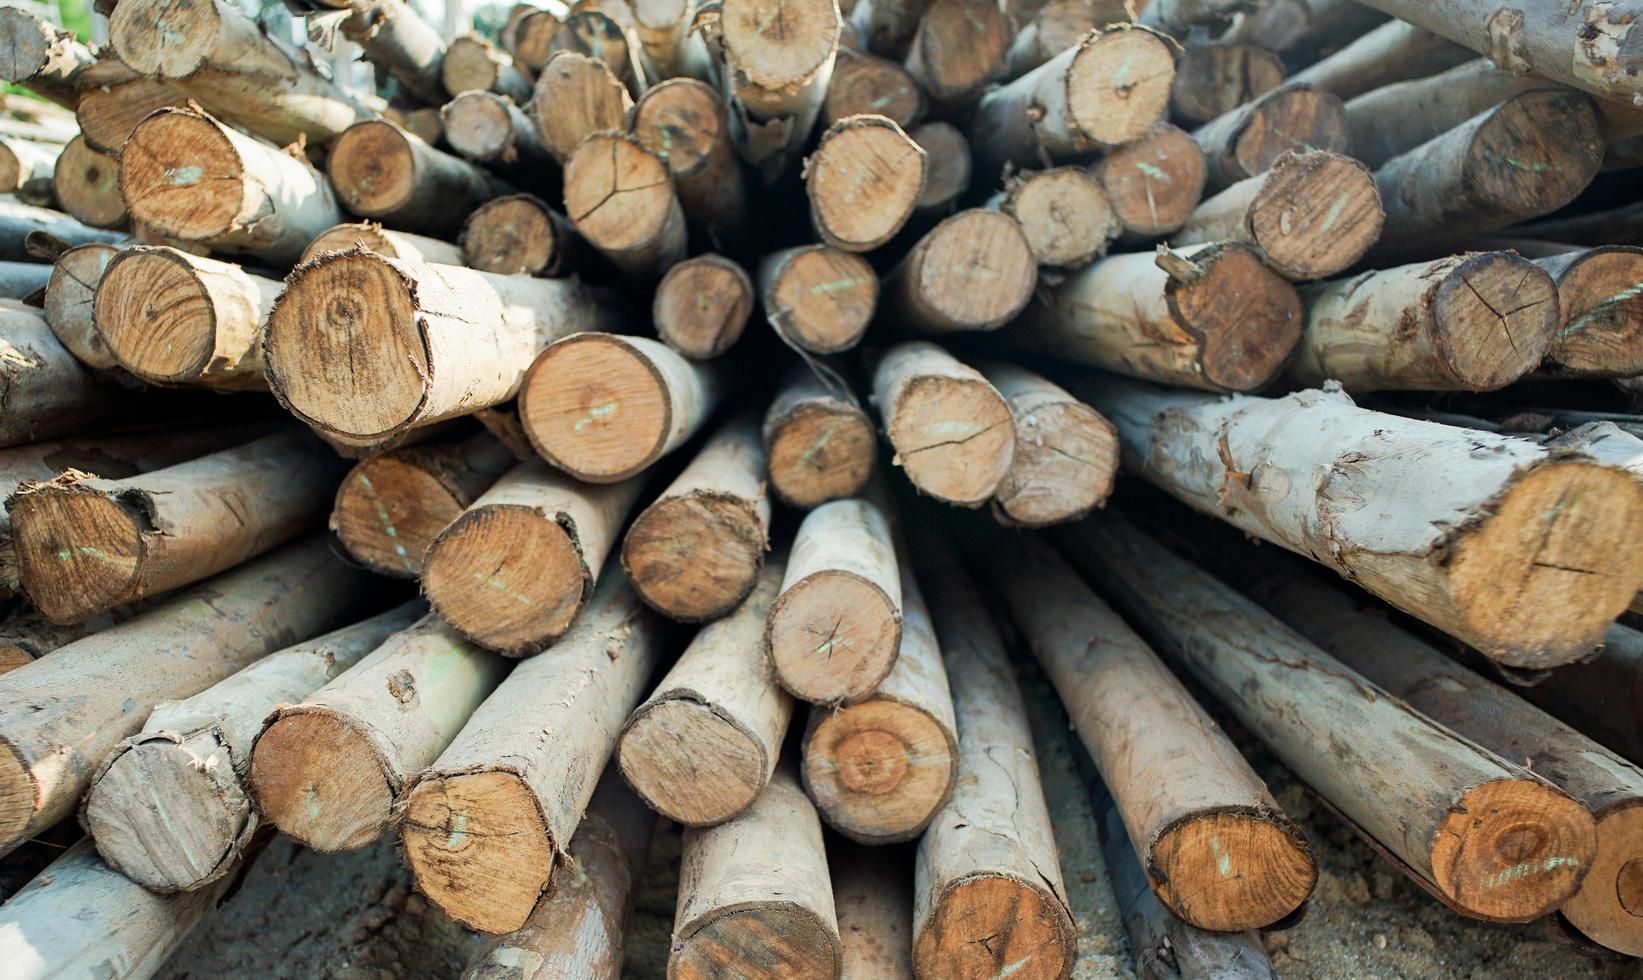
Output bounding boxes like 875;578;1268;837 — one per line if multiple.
1093;123;1208;240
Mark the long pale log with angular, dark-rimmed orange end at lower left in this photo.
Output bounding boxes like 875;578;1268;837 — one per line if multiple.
396;574;667;934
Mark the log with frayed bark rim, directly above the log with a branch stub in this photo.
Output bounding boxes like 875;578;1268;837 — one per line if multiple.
1170;150;1383;281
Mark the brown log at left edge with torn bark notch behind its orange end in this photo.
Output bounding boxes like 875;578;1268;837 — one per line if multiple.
7;429;342;623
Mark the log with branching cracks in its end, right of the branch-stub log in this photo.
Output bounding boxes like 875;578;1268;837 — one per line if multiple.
1286;252;1561;391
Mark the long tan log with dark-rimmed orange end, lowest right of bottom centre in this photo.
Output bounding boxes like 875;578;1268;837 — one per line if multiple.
978;538;1318;932
